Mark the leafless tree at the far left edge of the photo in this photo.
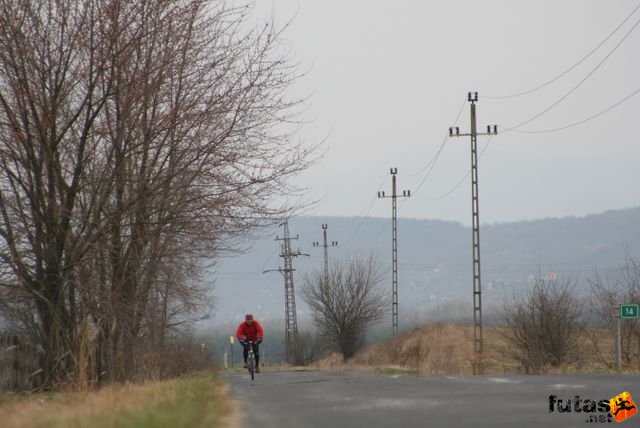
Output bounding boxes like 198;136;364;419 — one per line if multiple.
0;1;116;388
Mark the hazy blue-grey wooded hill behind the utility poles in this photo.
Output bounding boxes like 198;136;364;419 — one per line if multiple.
211;208;640;324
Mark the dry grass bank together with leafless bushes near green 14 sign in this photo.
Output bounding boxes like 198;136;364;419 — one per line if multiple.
300;257;640;375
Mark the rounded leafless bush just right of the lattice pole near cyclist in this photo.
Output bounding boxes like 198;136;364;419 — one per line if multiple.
302;257;387;360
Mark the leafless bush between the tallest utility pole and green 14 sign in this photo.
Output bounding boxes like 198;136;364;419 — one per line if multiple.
503;279;582;373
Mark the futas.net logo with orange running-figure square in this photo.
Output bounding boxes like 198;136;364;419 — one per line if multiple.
549;391;638;423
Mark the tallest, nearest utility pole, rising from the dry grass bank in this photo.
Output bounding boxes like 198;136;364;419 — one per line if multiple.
449;92;498;374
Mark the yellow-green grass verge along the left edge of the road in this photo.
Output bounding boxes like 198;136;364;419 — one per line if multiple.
0;373;234;428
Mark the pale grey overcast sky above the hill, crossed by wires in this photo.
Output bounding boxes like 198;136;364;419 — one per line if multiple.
250;0;640;224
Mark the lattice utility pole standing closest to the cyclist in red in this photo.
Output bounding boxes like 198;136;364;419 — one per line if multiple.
263;219;309;363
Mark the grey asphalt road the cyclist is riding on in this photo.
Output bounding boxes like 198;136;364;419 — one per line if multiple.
223;371;640;428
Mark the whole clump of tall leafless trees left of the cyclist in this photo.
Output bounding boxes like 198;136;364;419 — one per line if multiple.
0;0;313;385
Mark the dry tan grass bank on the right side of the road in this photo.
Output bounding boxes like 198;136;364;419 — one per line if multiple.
314;324;632;375
